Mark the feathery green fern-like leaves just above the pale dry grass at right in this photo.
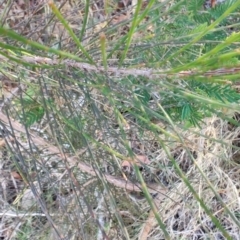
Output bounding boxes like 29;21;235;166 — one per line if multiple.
158;80;240;126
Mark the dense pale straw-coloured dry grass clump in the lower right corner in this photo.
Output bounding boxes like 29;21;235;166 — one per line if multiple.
148;117;240;239
